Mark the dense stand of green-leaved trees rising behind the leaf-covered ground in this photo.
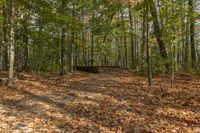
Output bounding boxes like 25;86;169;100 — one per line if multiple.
0;0;200;83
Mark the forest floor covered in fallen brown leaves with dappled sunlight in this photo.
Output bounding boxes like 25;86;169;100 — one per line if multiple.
0;71;200;133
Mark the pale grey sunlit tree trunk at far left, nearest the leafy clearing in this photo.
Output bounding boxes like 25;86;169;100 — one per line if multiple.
8;0;15;87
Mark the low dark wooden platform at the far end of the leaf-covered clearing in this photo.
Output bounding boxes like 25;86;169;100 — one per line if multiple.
76;66;122;73
